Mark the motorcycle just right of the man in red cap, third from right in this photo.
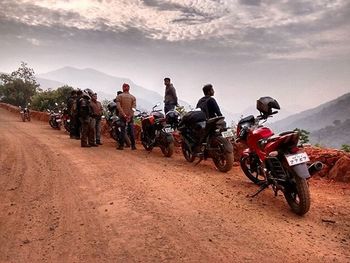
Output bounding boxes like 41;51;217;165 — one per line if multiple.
136;103;174;157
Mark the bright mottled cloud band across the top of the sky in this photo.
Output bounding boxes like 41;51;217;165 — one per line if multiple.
0;0;350;59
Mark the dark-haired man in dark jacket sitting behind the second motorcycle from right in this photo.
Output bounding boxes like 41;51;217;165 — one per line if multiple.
196;84;222;119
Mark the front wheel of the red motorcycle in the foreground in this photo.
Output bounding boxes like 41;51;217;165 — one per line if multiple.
240;156;266;185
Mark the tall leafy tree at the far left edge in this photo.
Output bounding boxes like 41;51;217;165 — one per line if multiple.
0;62;40;106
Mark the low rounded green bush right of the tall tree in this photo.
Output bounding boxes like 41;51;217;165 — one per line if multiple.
32;85;73;111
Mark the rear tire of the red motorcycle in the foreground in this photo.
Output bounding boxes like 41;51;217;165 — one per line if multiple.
284;175;310;216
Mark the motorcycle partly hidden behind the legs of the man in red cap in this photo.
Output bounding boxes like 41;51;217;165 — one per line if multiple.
105;102;131;147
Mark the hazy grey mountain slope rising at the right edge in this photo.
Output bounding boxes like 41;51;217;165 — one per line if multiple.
271;93;350;132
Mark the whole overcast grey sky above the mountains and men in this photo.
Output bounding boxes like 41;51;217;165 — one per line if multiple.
0;0;350;113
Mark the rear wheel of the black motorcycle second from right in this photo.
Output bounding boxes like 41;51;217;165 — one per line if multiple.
210;137;233;173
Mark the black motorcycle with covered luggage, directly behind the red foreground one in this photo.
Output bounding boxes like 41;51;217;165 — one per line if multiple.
178;110;233;172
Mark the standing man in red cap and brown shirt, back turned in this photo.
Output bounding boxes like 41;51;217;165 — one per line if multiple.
116;83;136;150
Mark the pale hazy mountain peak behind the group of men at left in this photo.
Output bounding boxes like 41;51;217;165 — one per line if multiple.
38;67;188;110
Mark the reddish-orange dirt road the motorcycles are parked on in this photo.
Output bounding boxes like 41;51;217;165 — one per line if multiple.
0;109;350;262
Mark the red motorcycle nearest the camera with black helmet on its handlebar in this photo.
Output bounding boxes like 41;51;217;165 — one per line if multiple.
236;97;323;215
